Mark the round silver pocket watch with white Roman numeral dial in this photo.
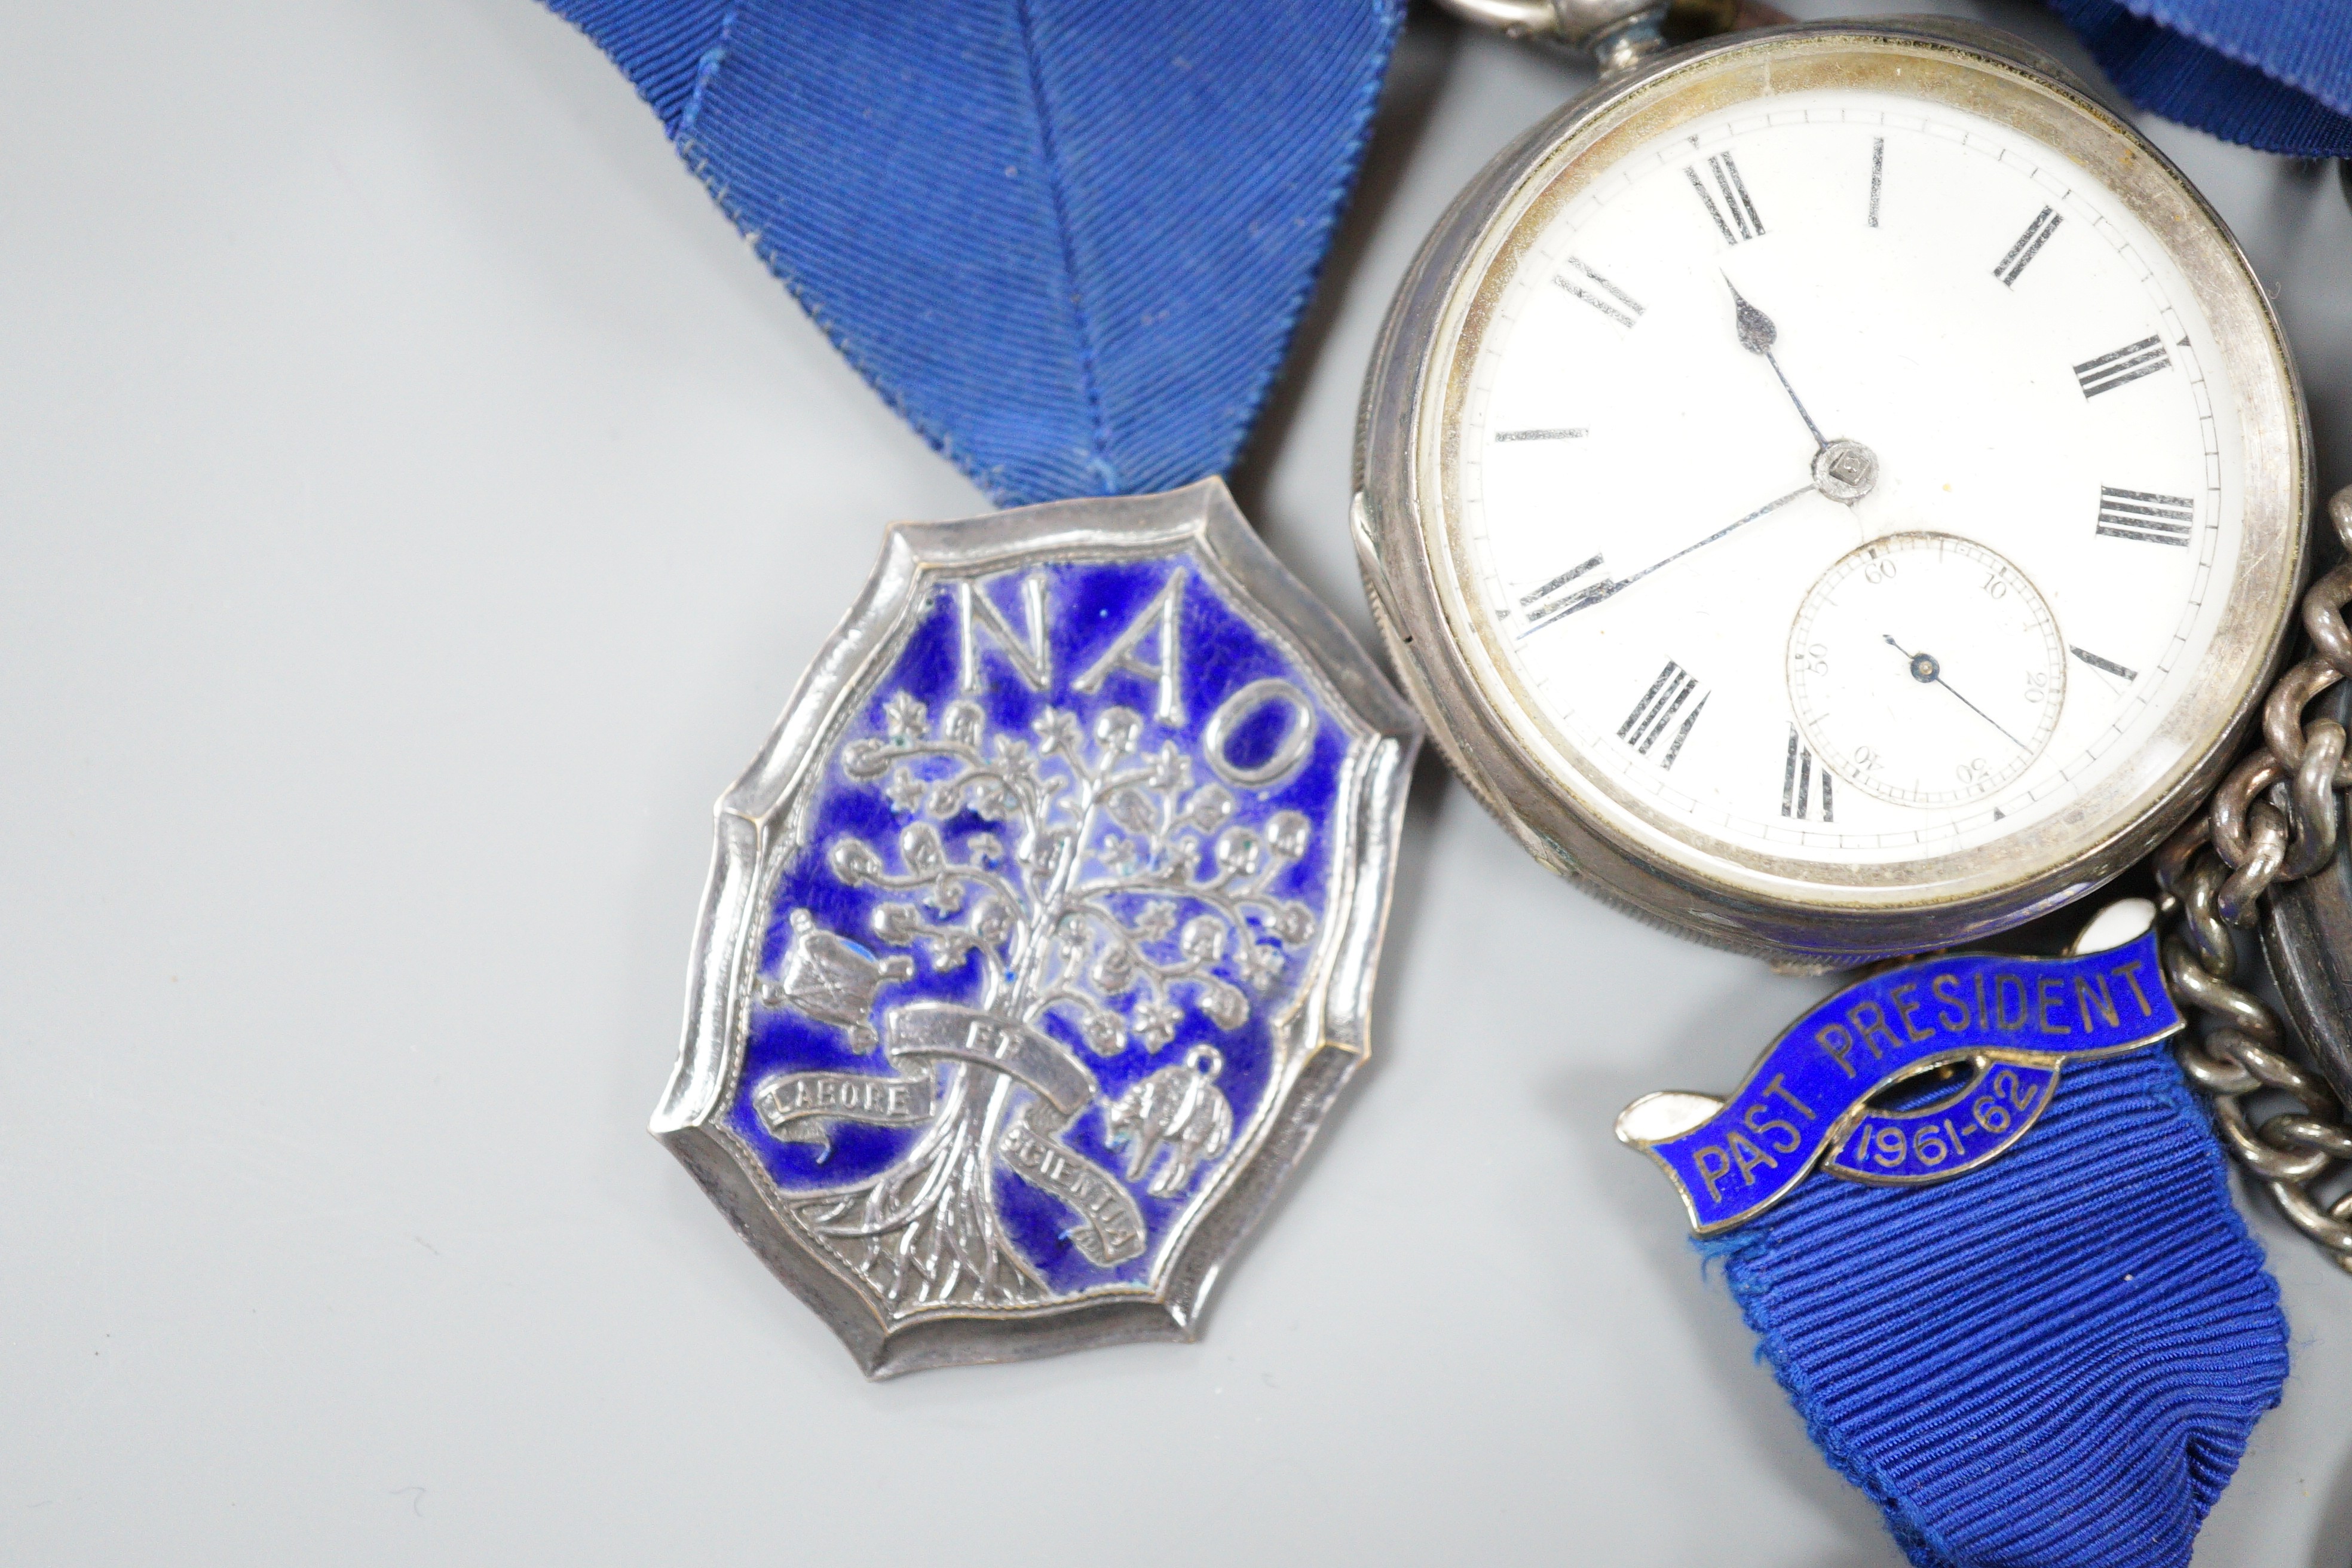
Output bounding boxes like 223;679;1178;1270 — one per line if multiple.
1364;26;2302;950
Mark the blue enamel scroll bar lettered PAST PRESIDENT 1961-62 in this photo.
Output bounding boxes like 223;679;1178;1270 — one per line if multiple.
1616;905;2183;1236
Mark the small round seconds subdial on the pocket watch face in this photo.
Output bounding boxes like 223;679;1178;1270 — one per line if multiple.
1787;534;2068;806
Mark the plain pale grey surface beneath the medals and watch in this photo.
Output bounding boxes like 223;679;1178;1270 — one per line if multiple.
0;0;2352;1568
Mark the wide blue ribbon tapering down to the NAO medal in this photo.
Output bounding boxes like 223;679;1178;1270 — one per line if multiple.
548;0;1402;506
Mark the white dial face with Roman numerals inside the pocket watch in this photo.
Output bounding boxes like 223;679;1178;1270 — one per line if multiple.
1458;89;2244;865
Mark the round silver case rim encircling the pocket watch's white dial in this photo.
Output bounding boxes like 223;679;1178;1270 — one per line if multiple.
1352;19;2312;966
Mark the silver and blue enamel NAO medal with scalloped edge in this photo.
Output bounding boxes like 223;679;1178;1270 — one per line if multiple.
654;480;1420;1375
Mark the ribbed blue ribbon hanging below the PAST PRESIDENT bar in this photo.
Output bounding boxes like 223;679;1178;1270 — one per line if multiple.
1698;1051;2286;1568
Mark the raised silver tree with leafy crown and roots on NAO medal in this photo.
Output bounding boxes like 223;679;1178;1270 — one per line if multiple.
797;691;1315;1312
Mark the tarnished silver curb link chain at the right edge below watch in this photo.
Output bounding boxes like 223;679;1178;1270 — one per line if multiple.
2154;486;2352;1274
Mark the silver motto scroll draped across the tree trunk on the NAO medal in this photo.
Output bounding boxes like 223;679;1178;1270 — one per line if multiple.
751;1002;1143;1267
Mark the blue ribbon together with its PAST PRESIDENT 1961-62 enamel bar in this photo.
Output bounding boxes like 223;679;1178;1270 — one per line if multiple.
1618;936;2286;1568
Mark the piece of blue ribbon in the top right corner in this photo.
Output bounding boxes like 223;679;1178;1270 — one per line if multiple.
2051;0;2352;158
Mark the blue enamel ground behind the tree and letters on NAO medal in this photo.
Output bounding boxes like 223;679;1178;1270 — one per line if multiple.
727;552;1348;1296
